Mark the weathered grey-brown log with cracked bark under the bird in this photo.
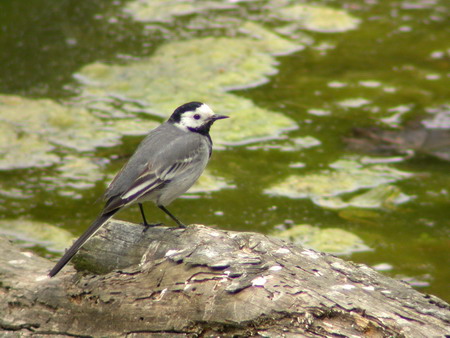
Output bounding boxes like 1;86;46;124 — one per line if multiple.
0;221;450;337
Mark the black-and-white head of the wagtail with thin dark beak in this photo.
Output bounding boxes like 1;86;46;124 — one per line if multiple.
169;102;228;134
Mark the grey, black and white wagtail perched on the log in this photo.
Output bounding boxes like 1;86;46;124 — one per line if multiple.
49;102;228;277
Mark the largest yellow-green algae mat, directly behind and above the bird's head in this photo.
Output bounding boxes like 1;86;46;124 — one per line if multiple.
77;33;296;145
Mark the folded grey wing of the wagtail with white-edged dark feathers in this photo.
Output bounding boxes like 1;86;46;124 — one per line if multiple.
103;134;209;213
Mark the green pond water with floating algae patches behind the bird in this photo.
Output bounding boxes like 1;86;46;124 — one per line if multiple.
0;0;450;300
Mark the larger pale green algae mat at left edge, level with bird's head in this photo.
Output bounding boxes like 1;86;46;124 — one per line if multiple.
0;95;119;170
